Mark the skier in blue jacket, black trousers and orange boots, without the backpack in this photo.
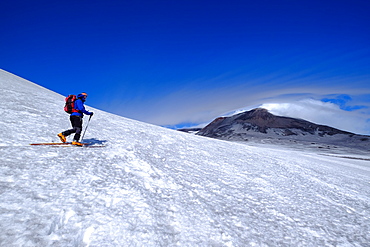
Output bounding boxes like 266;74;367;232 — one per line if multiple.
58;93;94;146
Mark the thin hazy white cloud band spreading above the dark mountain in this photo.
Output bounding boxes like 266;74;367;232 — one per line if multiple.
114;88;370;134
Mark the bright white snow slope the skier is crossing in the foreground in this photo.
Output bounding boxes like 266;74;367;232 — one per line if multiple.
0;70;370;246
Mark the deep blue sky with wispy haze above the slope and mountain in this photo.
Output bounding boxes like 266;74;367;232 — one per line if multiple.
0;0;370;134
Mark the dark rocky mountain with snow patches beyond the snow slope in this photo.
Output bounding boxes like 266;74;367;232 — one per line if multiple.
198;108;368;149
